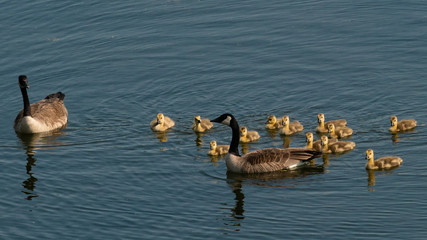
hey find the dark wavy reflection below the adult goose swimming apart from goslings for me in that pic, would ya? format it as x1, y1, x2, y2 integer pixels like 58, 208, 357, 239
16, 131, 64, 200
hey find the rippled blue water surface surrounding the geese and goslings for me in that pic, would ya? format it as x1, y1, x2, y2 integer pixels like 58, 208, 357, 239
0, 0, 427, 239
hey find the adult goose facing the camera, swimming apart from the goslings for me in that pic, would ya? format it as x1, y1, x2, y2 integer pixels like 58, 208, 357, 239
13, 75, 68, 133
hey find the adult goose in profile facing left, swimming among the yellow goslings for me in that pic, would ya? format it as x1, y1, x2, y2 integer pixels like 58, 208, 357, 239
211, 113, 320, 173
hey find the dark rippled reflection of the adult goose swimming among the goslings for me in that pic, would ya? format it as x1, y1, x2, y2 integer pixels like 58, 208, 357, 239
225, 165, 326, 231
